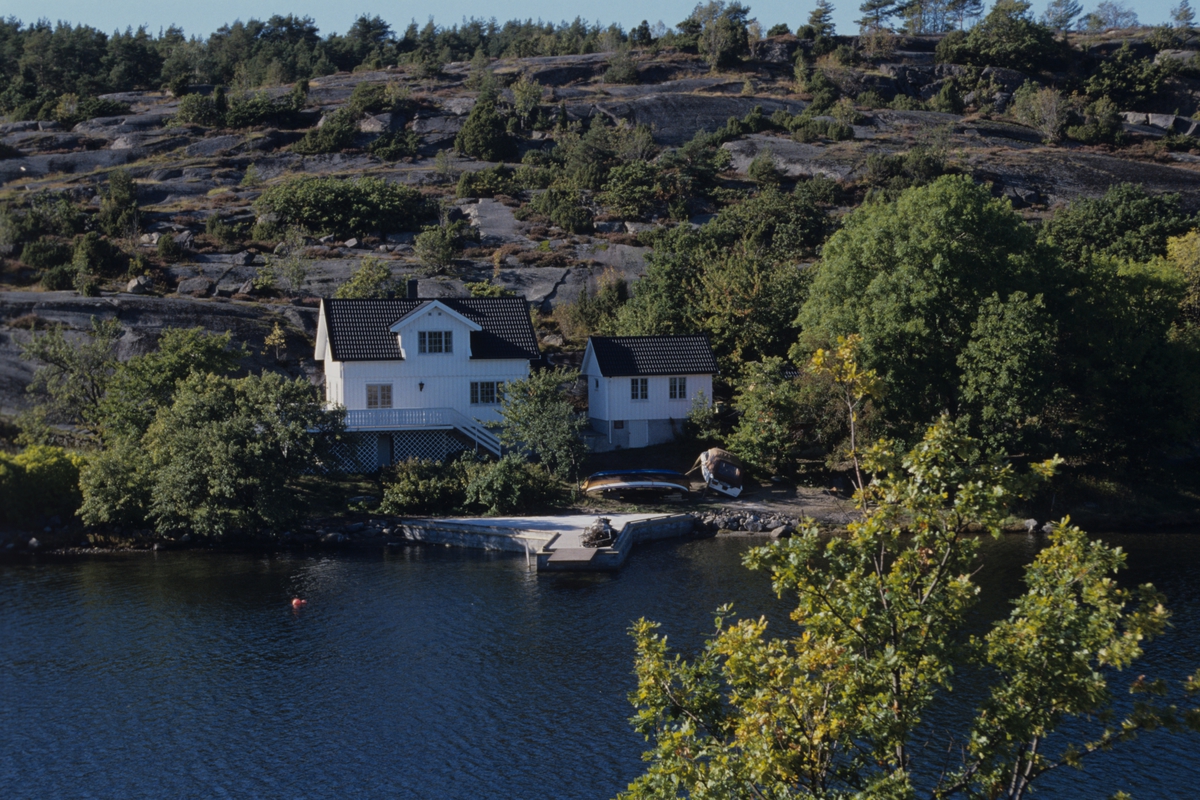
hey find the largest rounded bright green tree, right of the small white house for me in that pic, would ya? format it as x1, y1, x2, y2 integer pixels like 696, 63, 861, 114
793, 176, 1056, 435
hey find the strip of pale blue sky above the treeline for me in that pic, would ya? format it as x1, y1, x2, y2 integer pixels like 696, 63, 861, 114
9, 0, 1185, 36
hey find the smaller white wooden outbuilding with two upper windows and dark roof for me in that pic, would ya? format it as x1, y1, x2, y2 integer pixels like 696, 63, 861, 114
581, 335, 718, 449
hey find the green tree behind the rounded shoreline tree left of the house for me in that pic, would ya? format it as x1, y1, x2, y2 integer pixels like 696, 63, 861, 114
97, 327, 248, 443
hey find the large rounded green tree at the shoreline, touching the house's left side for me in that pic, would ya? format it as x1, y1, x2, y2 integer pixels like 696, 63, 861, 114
144, 373, 341, 536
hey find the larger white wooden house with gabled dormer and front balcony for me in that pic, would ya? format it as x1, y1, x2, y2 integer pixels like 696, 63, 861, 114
316, 292, 540, 469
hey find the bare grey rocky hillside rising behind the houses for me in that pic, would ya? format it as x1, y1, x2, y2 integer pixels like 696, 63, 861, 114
0, 36, 1200, 413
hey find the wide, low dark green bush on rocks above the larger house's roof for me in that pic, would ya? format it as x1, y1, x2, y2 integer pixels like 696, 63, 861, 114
256, 175, 425, 235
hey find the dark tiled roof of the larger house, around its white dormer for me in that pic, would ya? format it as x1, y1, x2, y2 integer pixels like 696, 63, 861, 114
320, 297, 541, 361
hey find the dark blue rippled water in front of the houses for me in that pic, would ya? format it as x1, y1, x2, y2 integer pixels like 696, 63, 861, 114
0, 534, 1200, 800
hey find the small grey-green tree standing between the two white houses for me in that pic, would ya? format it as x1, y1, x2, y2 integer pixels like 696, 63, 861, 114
499, 367, 587, 481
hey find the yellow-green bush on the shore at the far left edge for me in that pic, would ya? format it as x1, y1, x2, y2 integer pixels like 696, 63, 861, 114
0, 445, 83, 524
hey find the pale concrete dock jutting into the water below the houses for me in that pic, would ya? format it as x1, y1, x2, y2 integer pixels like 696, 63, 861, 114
403, 513, 696, 572
